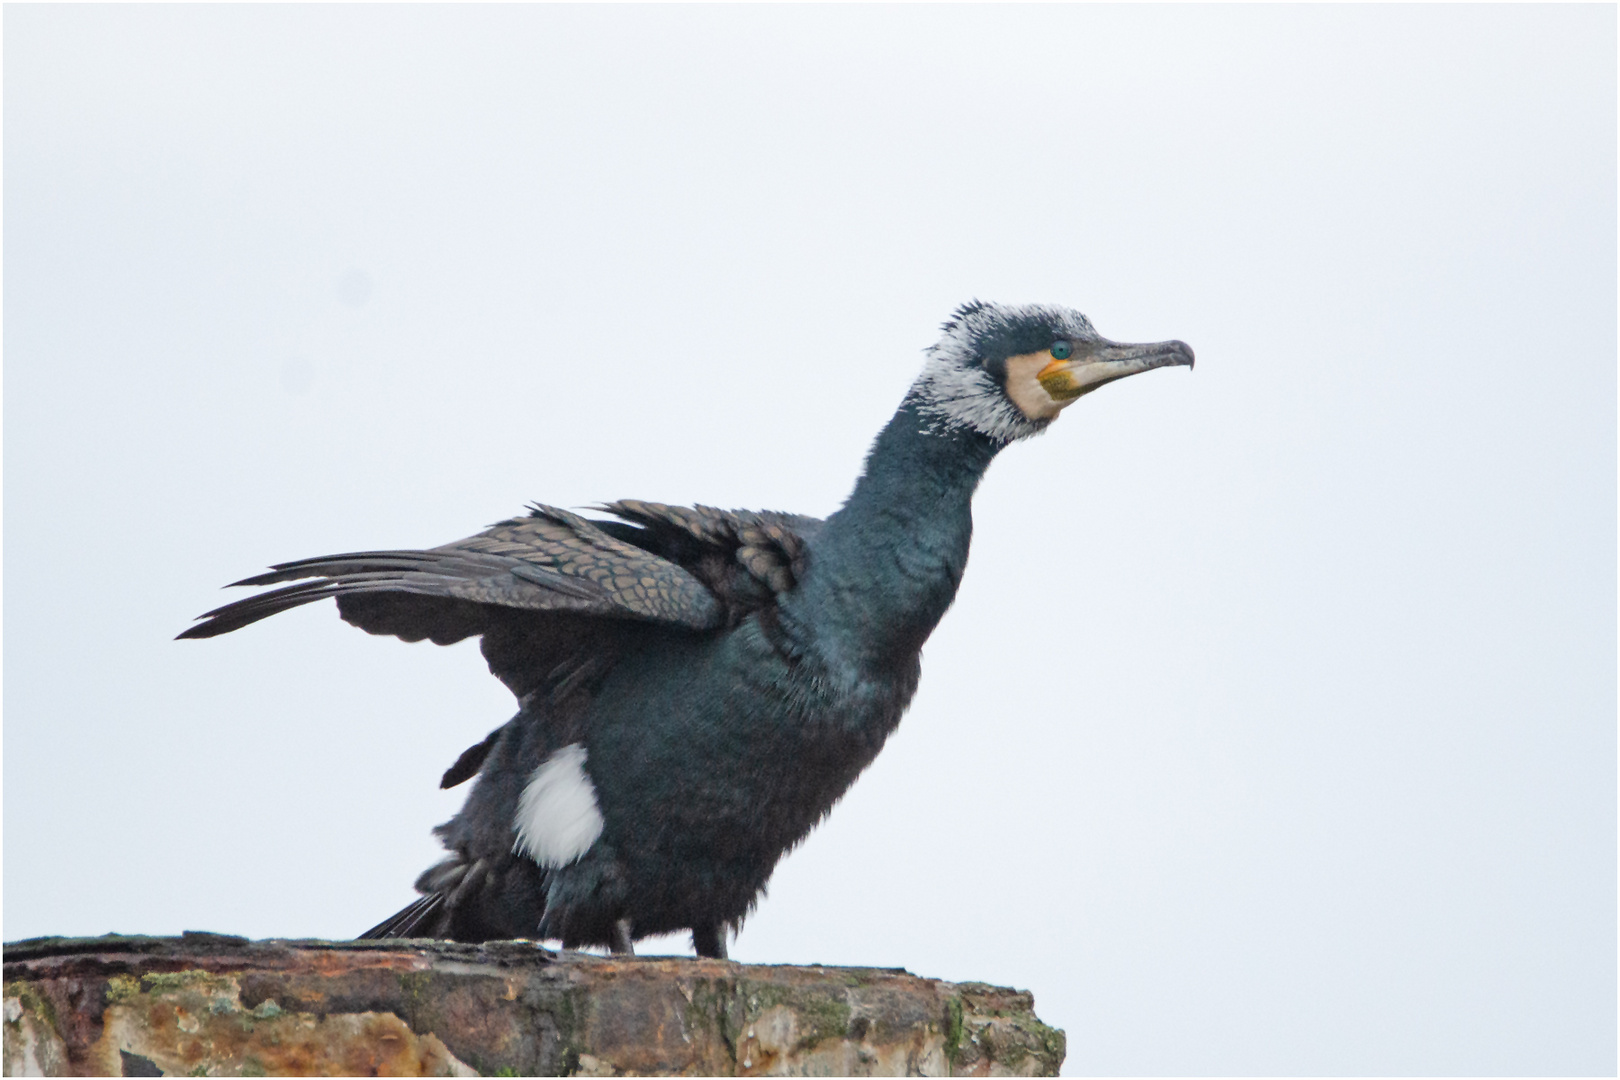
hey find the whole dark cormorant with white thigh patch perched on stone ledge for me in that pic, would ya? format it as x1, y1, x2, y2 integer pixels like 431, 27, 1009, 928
180, 301, 1192, 957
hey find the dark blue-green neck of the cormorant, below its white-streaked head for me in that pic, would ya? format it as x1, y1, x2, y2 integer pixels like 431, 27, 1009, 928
804, 392, 1001, 669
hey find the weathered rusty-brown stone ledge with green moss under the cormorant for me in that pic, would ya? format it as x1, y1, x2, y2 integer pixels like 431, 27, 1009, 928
3, 934, 1064, 1077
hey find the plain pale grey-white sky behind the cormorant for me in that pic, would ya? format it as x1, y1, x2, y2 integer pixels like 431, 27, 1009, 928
3, 5, 1615, 1074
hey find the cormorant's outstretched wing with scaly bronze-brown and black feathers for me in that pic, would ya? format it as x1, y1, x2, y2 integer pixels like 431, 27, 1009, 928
180, 500, 821, 787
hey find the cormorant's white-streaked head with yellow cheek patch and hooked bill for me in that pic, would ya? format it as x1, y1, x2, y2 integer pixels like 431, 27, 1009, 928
912, 300, 1192, 442
